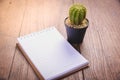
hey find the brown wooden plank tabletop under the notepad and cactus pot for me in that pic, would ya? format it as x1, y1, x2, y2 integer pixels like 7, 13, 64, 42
0, 0, 120, 80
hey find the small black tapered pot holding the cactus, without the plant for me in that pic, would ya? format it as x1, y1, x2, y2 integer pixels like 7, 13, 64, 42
64, 17, 89, 44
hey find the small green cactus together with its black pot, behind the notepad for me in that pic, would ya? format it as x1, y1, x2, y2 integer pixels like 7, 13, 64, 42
64, 4, 89, 44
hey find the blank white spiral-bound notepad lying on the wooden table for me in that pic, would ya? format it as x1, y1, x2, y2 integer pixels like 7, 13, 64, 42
17, 27, 89, 80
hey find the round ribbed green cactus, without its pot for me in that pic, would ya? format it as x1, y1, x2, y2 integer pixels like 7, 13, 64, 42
69, 4, 87, 25
